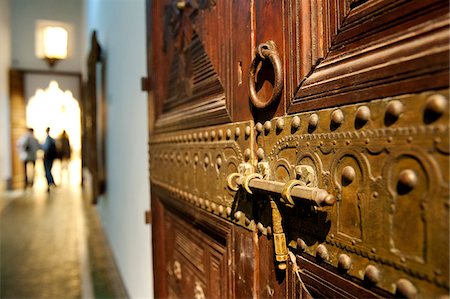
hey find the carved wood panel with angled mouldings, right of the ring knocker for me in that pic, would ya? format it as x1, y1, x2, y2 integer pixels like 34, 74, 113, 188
284, 0, 449, 113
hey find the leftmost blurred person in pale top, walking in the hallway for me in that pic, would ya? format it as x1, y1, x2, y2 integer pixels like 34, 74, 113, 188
17, 128, 41, 189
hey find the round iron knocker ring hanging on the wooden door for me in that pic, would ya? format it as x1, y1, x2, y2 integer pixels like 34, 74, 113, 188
249, 40, 283, 109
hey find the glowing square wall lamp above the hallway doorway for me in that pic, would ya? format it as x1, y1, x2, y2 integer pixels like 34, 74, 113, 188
36, 21, 69, 68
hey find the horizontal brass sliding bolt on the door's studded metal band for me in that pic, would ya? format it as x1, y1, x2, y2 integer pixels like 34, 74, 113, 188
227, 173, 336, 207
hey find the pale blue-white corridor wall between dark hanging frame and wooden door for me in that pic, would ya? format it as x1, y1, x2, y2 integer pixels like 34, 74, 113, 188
84, 0, 153, 298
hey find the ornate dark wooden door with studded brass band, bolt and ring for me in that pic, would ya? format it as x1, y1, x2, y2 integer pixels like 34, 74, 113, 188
146, 0, 449, 298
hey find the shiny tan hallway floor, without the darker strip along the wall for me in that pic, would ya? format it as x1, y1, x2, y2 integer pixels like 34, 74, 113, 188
0, 161, 86, 298
